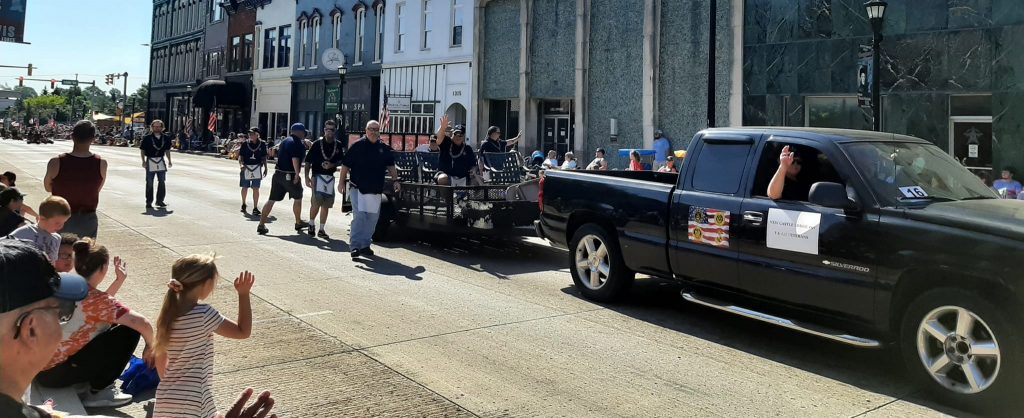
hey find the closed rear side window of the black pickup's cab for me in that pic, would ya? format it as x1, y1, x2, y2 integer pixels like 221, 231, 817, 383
693, 142, 752, 195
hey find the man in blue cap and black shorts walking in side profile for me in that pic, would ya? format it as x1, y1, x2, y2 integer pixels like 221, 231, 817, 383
256, 123, 310, 235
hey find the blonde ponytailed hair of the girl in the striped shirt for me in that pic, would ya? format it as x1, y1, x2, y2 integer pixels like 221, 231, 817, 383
153, 254, 218, 353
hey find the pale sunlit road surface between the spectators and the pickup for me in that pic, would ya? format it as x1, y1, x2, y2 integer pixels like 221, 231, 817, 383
0, 140, 964, 417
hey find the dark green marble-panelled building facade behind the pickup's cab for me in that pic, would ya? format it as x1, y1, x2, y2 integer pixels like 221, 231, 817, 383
742, 0, 1024, 175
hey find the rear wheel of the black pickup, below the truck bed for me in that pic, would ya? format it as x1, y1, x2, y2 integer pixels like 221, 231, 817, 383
569, 223, 635, 302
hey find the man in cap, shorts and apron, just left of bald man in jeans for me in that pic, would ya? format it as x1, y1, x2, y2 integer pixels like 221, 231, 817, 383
305, 121, 345, 240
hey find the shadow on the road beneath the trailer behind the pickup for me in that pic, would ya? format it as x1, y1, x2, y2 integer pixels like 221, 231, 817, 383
374, 233, 566, 280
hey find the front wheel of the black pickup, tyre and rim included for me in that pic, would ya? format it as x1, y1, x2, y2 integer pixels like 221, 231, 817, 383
900, 288, 1024, 412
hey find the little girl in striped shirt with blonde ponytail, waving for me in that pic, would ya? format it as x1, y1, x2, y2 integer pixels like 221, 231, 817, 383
153, 254, 256, 418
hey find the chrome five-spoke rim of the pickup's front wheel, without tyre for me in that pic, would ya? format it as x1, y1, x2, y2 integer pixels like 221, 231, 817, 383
918, 306, 1001, 394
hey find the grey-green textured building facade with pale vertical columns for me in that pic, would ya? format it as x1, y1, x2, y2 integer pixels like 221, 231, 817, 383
473, 0, 742, 166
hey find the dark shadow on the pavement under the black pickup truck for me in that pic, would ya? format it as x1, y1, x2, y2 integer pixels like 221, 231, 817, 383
562, 278, 970, 416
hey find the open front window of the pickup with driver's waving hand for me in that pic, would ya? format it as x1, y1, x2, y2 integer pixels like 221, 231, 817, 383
751, 141, 846, 202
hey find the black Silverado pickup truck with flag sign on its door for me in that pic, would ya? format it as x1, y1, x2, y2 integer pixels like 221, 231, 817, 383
537, 128, 1024, 410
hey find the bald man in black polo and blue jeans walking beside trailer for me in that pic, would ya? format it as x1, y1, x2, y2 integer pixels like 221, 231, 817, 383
338, 121, 399, 259
